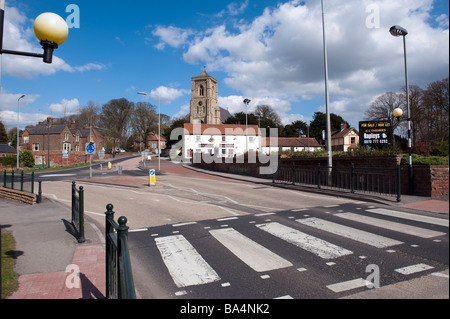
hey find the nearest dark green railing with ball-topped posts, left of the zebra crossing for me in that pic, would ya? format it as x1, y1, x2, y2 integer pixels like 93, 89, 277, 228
105, 204, 136, 299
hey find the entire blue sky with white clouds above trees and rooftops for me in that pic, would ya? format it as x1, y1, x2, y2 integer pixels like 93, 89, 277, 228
0, 0, 449, 131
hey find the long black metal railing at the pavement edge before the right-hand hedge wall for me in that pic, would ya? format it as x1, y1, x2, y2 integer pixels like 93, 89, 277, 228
272, 164, 401, 202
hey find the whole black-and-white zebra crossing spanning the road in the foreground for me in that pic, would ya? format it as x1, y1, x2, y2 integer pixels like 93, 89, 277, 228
129, 205, 448, 299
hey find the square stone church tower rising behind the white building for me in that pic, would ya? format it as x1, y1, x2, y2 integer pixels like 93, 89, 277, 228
190, 71, 222, 124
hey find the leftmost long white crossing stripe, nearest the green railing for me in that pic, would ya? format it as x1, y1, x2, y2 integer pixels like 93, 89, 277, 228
155, 235, 220, 288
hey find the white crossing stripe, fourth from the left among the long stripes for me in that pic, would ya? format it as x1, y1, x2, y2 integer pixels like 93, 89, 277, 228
296, 218, 403, 248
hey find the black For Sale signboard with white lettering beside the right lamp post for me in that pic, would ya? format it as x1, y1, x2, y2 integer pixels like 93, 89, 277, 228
359, 121, 392, 147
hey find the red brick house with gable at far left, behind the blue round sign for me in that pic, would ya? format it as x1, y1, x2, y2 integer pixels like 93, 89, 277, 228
20, 117, 104, 165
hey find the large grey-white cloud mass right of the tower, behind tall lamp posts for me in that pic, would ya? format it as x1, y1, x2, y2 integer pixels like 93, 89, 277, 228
151, 0, 449, 127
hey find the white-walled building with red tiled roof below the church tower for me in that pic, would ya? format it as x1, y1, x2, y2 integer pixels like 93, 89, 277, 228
183, 123, 261, 161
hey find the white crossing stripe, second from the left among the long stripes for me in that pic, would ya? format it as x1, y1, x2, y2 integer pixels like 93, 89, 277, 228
209, 228, 292, 272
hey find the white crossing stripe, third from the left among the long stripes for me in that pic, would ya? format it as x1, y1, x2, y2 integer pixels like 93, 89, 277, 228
256, 223, 353, 259
